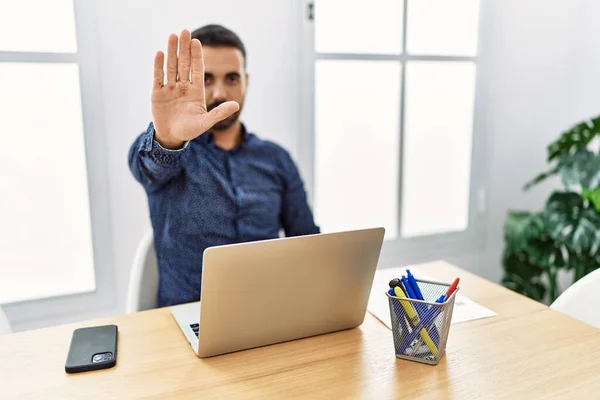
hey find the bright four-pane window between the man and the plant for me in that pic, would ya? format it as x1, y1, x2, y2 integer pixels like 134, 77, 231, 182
300, 0, 483, 260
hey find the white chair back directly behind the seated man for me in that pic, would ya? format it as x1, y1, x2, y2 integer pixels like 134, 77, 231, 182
126, 231, 158, 314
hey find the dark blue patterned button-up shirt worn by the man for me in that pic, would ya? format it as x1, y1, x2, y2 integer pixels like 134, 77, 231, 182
129, 123, 319, 307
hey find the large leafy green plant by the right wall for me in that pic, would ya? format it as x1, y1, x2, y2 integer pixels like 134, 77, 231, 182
502, 116, 600, 302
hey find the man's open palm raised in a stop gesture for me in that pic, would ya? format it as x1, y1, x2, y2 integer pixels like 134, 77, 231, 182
152, 30, 239, 149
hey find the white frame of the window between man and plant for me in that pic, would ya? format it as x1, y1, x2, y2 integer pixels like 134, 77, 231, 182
298, 0, 488, 268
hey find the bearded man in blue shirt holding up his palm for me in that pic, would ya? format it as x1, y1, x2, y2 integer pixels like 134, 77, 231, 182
129, 25, 319, 307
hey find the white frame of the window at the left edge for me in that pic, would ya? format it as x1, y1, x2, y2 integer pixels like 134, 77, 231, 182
0, 0, 117, 327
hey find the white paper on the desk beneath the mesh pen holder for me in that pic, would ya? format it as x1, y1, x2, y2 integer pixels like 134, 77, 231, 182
367, 268, 496, 329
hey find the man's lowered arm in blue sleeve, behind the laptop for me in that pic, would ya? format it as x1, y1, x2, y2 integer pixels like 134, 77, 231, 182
281, 152, 321, 236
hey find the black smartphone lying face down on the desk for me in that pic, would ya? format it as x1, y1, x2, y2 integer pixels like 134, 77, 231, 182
65, 325, 119, 374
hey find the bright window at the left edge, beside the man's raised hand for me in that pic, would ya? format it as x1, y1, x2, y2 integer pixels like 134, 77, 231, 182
0, 0, 107, 310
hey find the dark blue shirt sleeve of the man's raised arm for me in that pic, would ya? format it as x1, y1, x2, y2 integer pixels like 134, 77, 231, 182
129, 122, 189, 192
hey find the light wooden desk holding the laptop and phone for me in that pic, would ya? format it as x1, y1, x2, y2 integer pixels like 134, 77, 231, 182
0, 262, 600, 400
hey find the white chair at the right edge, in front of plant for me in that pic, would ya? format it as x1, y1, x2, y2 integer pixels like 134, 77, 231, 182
550, 269, 600, 328
